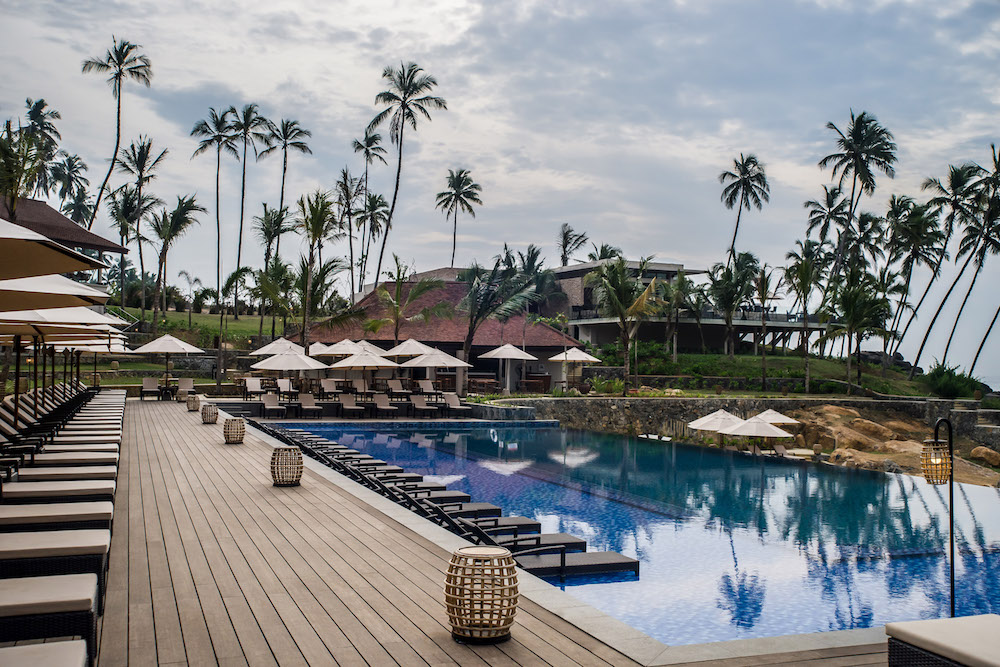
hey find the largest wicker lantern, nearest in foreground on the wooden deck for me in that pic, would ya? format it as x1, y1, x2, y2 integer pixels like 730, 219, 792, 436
444, 547, 518, 644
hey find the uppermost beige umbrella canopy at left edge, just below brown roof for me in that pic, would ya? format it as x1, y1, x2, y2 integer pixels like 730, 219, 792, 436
0, 218, 108, 280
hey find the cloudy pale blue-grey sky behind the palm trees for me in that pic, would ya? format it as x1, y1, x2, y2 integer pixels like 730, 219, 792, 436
0, 0, 1000, 385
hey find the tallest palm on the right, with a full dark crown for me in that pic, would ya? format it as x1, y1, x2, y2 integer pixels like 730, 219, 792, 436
819, 109, 896, 275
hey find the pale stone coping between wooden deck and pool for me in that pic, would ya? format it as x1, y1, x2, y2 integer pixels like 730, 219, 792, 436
238, 410, 886, 667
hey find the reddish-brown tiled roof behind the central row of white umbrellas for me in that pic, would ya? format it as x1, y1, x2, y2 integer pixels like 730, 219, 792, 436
309, 282, 581, 350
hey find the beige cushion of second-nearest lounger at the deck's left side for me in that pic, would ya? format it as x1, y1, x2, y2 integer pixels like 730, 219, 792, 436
0, 573, 97, 617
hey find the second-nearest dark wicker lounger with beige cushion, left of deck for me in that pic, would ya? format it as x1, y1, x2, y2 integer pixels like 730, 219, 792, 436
0, 574, 98, 665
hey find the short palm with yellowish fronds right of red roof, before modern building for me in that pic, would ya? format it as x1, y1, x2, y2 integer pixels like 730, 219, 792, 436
584, 257, 657, 395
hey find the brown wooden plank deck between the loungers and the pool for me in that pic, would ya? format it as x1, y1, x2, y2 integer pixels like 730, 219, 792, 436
99, 400, 635, 667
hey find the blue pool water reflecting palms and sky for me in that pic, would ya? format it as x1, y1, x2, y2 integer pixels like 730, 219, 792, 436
296, 424, 1000, 644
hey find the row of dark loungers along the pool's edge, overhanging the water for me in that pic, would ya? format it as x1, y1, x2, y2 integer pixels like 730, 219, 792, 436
255, 424, 639, 577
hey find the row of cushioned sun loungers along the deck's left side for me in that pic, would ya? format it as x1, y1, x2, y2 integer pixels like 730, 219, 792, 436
0, 383, 125, 667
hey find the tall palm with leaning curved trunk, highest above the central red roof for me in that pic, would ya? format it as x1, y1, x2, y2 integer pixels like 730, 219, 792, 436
367, 62, 448, 284
